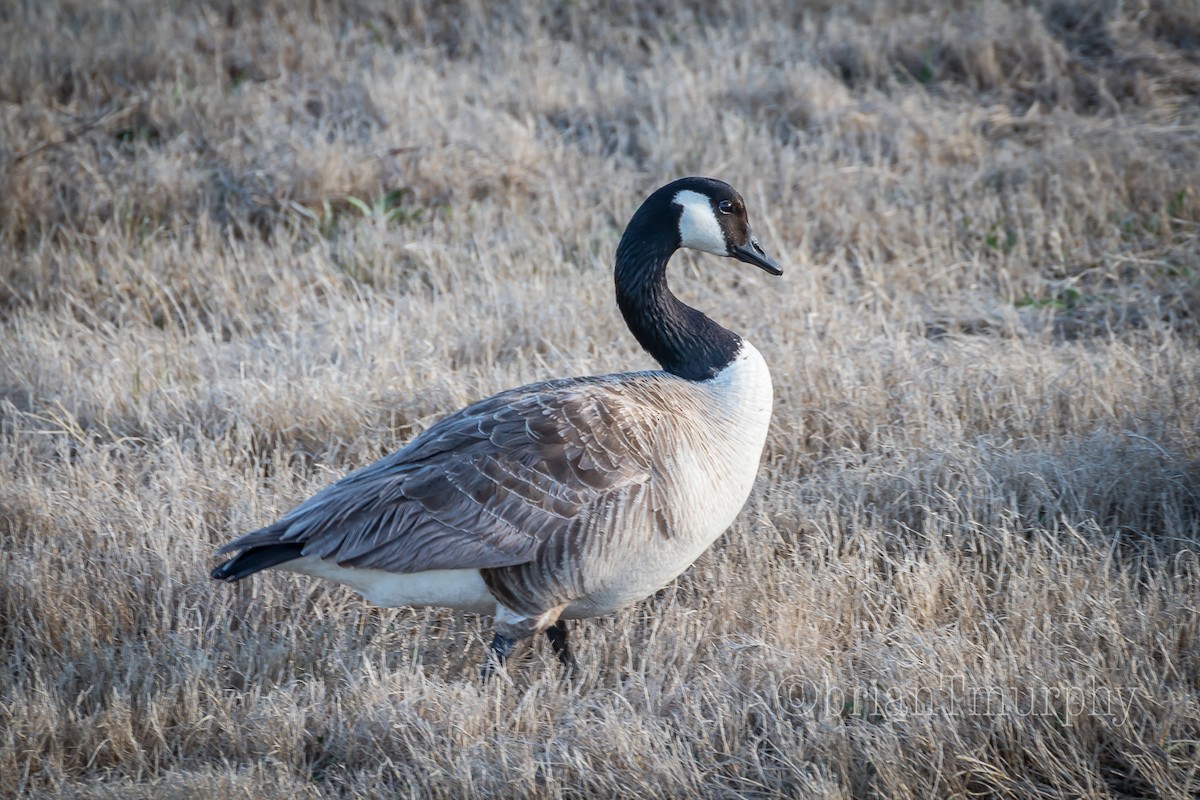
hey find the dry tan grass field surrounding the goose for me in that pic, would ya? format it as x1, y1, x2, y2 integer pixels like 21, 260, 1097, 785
0, 0, 1200, 799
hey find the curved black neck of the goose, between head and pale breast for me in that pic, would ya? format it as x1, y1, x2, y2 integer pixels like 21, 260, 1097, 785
616, 206, 742, 380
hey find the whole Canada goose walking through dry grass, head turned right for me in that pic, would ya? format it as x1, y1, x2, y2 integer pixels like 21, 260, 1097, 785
212, 178, 782, 675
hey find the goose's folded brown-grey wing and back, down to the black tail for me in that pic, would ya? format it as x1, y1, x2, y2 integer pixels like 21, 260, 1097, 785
220, 375, 661, 572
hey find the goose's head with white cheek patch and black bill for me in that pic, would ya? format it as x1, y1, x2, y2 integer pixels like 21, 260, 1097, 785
660, 178, 784, 275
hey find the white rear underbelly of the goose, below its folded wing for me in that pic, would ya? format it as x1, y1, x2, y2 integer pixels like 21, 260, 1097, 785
280, 555, 496, 614
